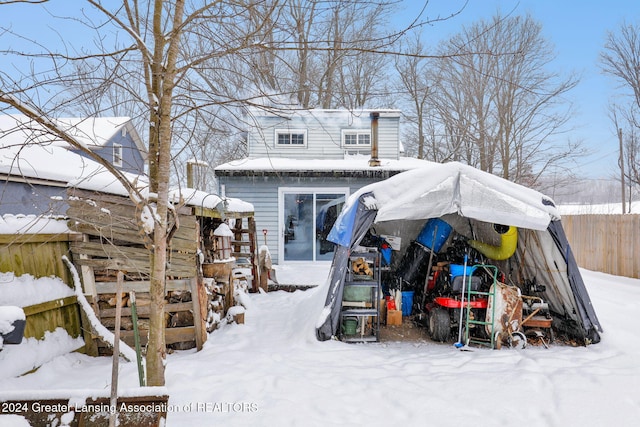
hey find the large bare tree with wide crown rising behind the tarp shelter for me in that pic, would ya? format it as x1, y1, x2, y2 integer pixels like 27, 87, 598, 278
424, 15, 579, 185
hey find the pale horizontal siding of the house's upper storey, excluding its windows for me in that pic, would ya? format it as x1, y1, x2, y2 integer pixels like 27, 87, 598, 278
248, 110, 400, 160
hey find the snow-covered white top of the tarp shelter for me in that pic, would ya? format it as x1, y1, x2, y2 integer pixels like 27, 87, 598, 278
345, 162, 560, 234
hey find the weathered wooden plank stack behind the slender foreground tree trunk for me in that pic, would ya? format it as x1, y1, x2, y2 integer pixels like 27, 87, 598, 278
67, 189, 208, 354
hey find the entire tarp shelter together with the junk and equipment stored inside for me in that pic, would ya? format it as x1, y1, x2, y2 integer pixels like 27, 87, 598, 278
316, 163, 602, 348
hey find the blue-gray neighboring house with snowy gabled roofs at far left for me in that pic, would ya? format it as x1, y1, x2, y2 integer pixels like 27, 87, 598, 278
0, 115, 146, 215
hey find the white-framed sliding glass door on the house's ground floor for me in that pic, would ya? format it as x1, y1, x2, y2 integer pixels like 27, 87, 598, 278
279, 188, 349, 261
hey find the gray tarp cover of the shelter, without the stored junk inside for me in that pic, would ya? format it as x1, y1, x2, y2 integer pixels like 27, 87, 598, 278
316, 162, 602, 344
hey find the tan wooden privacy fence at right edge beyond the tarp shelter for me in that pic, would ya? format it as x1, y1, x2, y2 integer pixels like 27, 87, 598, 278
562, 214, 640, 278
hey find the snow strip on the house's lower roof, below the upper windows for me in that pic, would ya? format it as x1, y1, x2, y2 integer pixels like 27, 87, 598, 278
215, 155, 430, 172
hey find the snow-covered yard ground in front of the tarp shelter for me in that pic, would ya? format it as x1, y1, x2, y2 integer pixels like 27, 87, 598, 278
0, 265, 640, 427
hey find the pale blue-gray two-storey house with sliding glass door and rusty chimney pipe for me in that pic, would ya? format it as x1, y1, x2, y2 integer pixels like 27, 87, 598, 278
215, 110, 424, 264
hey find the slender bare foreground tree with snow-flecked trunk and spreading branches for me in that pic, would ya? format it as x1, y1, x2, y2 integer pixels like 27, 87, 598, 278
0, 0, 286, 386
